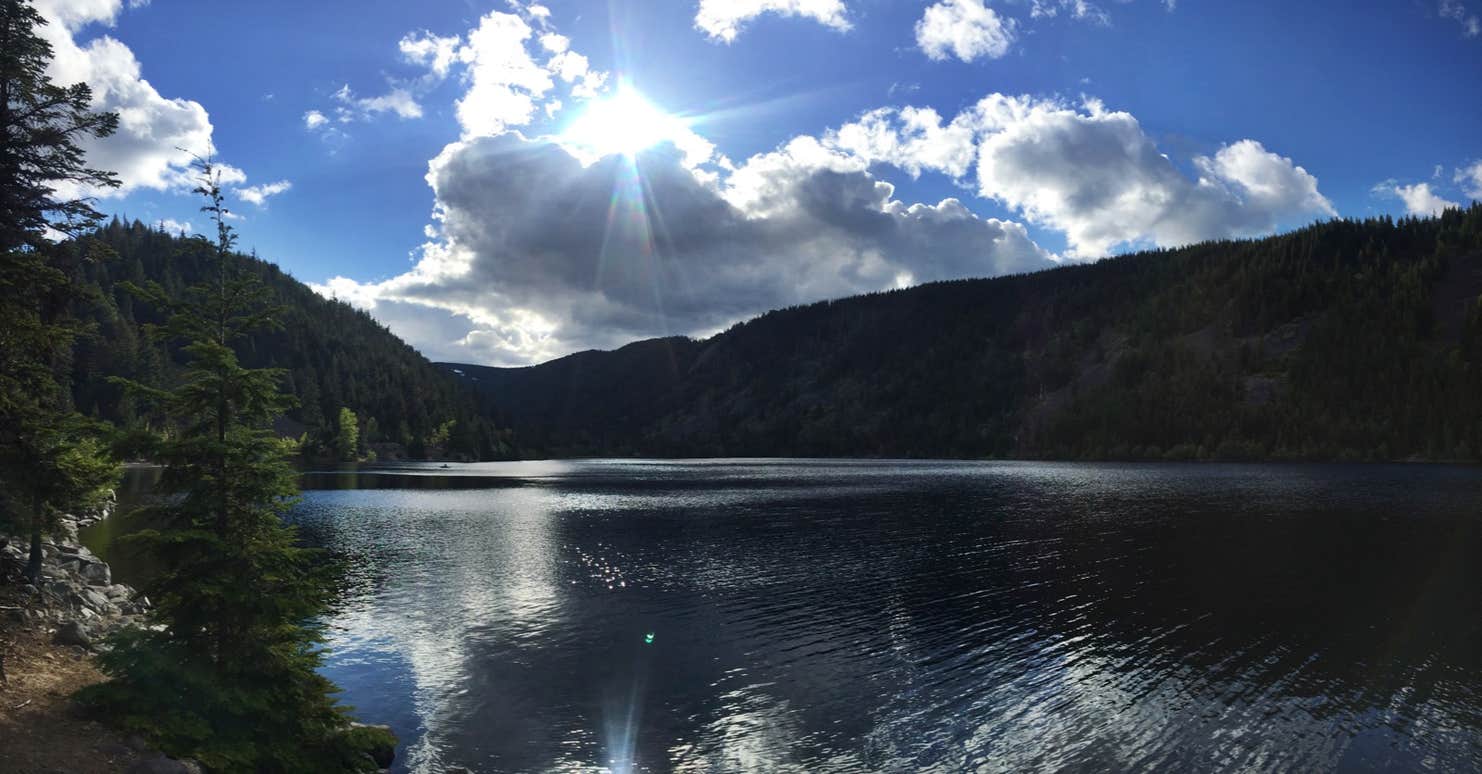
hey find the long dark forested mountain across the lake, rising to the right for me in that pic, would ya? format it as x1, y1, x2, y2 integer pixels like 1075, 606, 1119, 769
445, 205, 1482, 460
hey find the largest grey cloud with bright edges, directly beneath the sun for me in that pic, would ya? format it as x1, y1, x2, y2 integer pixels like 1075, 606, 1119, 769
312, 133, 1052, 362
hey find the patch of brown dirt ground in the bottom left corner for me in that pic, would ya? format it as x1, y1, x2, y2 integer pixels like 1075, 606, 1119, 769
0, 607, 141, 774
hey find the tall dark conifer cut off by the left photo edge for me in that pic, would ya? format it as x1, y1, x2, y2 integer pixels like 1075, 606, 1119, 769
0, 0, 119, 580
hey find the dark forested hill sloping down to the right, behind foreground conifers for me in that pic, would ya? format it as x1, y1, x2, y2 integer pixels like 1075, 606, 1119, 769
71, 219, 513, 460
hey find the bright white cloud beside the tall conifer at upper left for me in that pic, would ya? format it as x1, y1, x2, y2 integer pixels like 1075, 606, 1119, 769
34, 0, 212, 196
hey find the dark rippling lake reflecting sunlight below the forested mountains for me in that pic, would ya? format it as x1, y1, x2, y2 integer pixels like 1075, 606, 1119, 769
133, 460, 1482, 773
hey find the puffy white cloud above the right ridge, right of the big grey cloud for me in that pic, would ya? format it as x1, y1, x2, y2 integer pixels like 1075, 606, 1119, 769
824, 93, 1337, 258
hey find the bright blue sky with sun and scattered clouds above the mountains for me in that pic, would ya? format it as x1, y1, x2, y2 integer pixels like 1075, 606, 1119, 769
33, 0, 1482, 365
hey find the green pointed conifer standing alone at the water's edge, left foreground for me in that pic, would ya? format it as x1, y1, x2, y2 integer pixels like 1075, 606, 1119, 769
83, 162, 394, 773
